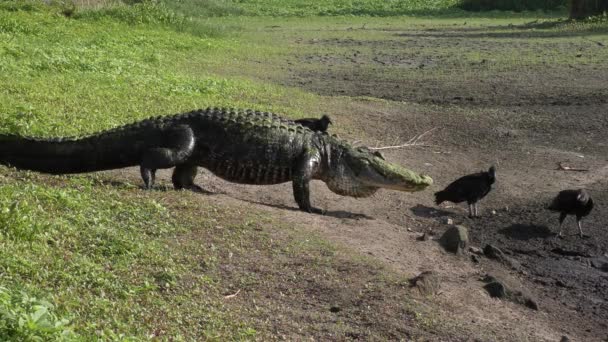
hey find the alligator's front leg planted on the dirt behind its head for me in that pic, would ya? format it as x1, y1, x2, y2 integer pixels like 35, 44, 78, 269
292, 153, 322, 214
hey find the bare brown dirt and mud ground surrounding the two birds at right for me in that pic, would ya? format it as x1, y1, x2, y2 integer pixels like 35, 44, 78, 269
117, 22, 608, 341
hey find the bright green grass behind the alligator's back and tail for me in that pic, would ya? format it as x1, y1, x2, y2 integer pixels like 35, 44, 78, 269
0, 1, 315, 136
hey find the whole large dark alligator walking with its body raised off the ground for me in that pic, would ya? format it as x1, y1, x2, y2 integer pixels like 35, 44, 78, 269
0, 108, 433, 212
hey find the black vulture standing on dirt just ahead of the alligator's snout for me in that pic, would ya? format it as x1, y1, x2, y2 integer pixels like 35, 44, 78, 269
435, 166, 496, 217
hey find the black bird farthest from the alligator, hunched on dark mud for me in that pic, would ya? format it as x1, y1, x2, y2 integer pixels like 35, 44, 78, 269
547, 189, 593, 237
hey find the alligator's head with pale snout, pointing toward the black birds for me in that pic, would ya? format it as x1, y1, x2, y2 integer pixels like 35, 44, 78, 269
323, 142, 433, 197
